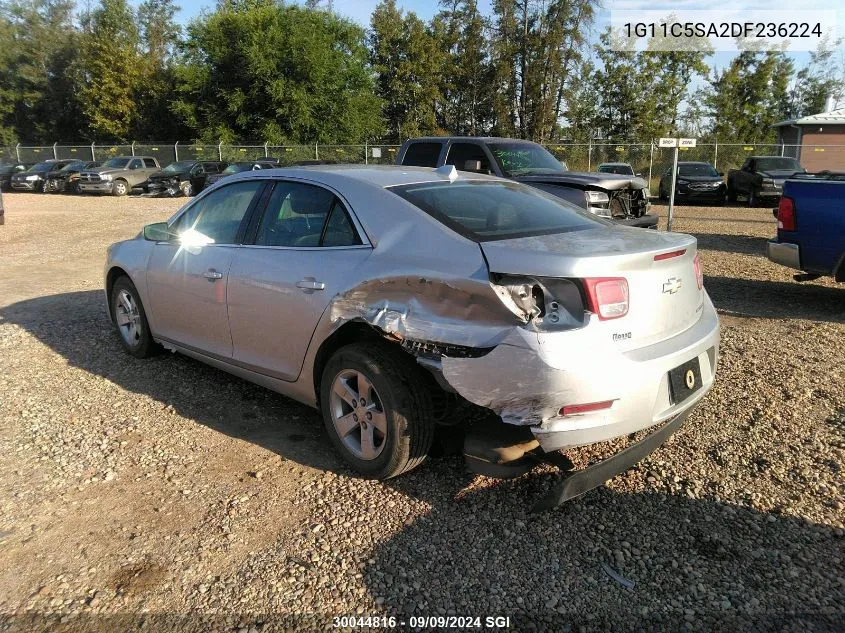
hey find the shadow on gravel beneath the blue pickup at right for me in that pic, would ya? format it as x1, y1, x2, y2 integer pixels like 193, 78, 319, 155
704, 274, 845, 323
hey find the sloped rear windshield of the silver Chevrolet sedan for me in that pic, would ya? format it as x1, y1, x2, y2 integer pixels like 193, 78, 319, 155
388, 180, 605, 242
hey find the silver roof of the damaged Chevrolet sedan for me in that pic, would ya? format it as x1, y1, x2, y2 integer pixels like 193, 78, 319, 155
231, 165, 502, 188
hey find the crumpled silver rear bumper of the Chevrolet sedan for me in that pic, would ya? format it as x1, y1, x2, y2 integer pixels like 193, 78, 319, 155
442, 294, 719, 452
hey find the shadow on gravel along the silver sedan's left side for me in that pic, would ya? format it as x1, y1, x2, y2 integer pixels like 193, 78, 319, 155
0, 290, 347, 472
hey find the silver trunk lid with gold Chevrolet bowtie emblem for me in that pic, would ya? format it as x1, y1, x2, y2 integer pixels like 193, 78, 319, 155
480, 227, 704, 349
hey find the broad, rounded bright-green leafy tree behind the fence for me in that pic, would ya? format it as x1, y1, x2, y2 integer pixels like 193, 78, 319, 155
173, 0, 382, 144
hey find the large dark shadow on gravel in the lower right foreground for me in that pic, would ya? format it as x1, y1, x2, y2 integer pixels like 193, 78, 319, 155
358, 460, 845, 631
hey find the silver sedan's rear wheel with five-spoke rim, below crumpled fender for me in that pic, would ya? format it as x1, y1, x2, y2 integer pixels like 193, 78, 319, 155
320, 343, 435, 479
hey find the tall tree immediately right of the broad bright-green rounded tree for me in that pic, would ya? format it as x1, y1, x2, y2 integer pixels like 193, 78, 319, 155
369, 0, 443, 141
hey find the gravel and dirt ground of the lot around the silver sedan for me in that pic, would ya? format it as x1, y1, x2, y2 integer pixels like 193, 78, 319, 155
0, 194, 845, 632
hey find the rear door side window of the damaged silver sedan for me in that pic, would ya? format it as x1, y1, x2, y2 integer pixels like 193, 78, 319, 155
255, 182, 361, 247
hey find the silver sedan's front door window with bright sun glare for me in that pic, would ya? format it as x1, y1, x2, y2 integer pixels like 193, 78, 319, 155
171, 180, 264, 245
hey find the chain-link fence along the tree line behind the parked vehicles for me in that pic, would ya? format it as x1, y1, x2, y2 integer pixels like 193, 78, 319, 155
0, 141, 828, 190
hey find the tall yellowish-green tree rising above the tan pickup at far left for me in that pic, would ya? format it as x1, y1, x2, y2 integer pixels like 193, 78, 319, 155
79, 0, 141, 141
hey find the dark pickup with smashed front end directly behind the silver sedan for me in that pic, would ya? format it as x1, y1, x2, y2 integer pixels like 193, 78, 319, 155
396, 136, 657, 228
